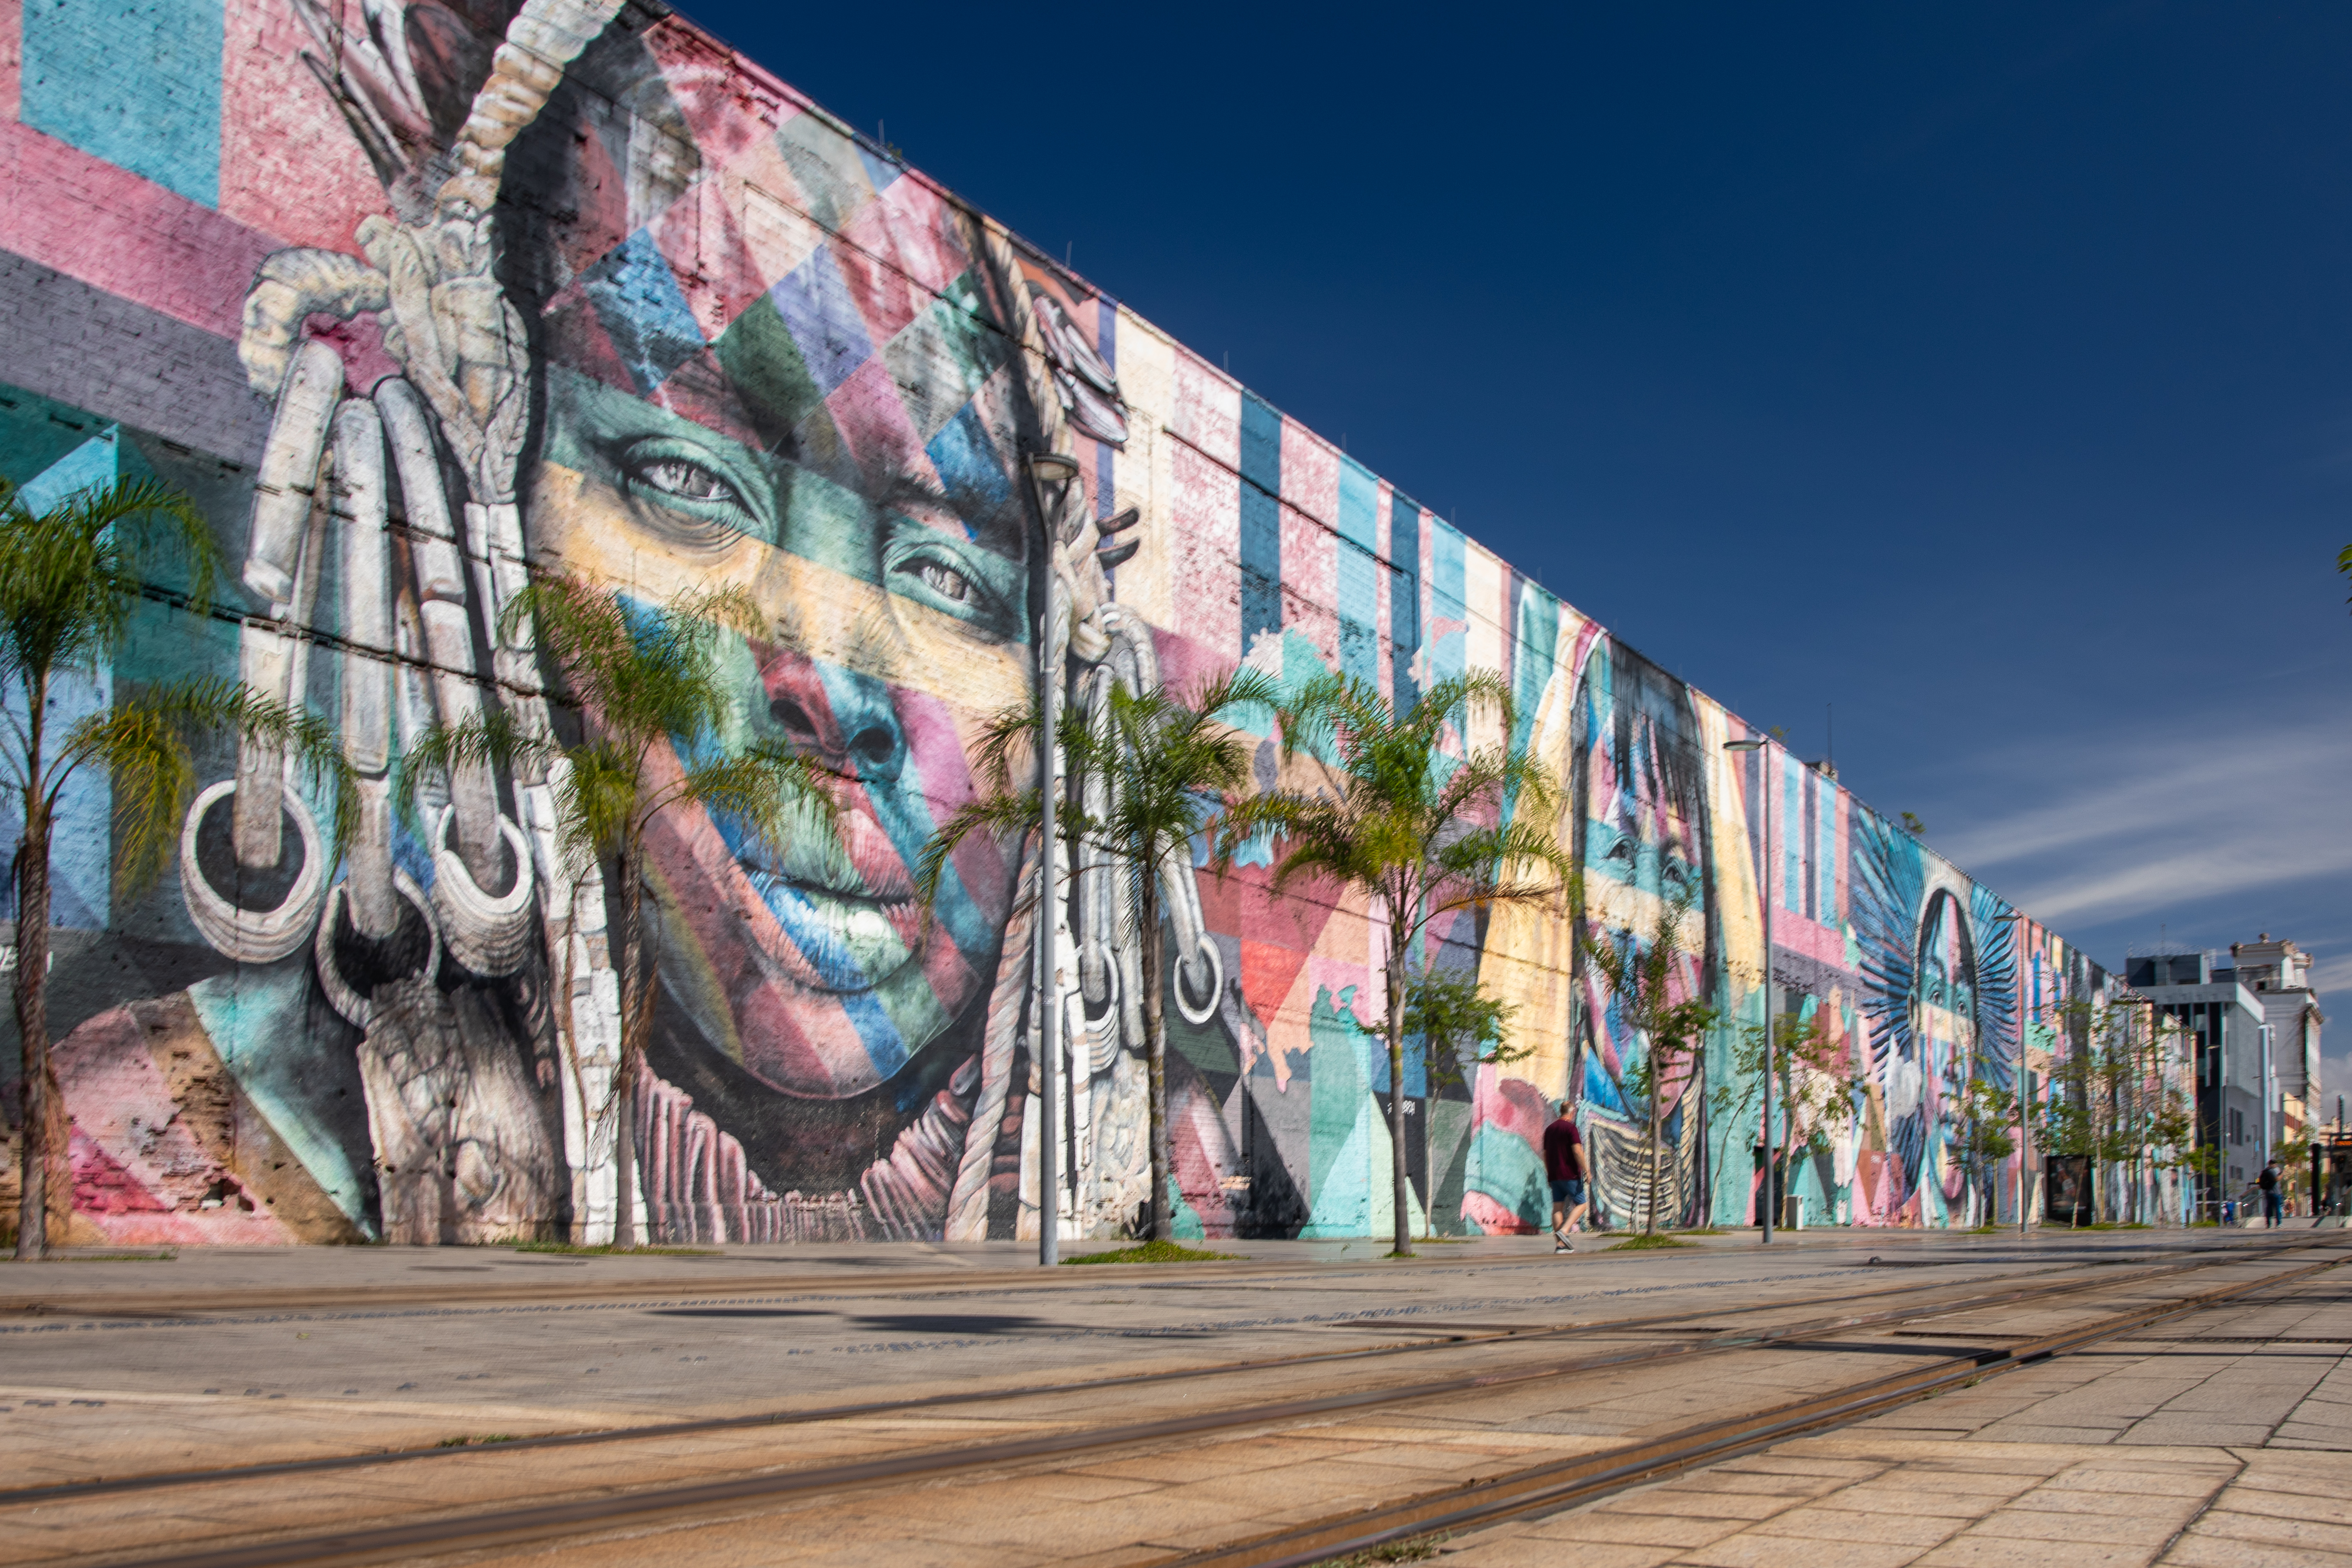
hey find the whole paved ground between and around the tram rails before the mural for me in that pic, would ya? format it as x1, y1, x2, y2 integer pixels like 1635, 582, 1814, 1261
0, 1232, 2352, 1568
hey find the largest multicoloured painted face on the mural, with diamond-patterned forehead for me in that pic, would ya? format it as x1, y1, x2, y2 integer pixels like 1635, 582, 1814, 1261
529, 175, 1028, 1098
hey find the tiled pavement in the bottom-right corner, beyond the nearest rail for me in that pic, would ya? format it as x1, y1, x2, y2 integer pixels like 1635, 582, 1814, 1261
1442, 1272, 2352, 1568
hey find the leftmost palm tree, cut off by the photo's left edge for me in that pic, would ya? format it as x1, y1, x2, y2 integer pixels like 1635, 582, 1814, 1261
0, 479, 358, 1258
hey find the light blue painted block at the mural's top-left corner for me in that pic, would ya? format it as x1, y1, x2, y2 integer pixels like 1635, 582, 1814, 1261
19, 0, 225, 207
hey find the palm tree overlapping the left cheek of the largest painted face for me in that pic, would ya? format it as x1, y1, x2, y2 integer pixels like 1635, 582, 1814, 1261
395, 576, 835, 1248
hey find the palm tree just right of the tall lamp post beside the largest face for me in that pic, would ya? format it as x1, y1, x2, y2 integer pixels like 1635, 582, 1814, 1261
919, 670, 1282, 1241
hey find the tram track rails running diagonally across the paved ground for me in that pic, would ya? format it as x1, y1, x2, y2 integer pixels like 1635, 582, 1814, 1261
27, 1237, 2340, 1568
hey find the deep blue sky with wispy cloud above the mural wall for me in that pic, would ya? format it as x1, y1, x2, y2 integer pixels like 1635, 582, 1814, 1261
684, 0, 2352, 1084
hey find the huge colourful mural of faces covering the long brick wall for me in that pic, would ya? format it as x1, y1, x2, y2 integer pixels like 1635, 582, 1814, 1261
0, 0, 2105, 1244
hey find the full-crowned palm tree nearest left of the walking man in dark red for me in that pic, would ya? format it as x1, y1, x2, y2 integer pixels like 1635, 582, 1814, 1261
1216, 670, 1578, 1258
